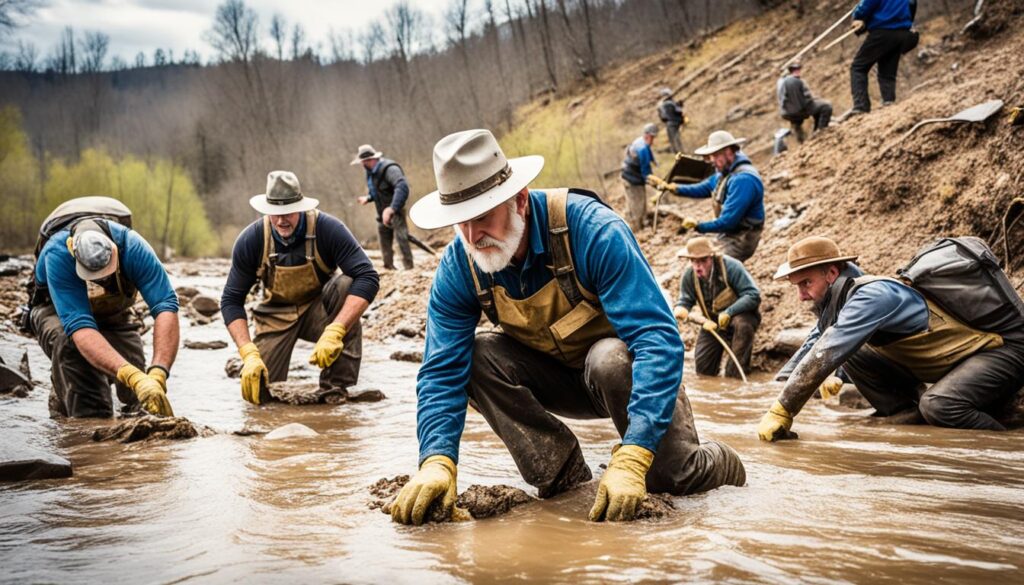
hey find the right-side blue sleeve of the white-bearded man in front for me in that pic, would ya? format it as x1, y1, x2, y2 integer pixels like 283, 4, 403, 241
569, 213, 683, 451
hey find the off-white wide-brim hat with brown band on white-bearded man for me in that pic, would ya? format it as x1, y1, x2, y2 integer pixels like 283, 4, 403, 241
409, 129, 544, 229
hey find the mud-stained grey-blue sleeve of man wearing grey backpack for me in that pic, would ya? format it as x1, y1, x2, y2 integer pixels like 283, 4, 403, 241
778, 281, 929, 415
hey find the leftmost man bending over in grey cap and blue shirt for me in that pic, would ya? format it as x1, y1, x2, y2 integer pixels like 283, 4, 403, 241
30, 197, 179, 417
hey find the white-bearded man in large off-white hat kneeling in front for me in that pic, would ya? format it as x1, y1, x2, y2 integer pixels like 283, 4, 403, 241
391, 130, 745, 524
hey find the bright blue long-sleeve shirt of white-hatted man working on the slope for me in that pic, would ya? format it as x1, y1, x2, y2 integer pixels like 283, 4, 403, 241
676, 152, 765, 234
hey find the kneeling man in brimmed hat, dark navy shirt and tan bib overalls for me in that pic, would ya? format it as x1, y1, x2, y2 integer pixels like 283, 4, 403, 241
220, 171, 380, 405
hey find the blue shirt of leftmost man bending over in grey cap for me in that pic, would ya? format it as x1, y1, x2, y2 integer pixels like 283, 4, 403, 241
36, 221, 178, 337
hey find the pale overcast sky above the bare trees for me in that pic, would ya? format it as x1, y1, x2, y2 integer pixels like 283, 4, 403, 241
7, 0, 452, 62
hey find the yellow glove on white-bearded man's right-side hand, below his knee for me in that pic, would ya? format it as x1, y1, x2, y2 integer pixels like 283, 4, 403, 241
590, 445, 654, 523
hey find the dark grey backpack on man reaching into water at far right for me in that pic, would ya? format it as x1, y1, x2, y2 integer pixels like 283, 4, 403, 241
897, 237, 1024, 335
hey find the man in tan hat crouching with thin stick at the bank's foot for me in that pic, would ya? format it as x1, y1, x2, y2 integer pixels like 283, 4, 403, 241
673, 236, 761, 378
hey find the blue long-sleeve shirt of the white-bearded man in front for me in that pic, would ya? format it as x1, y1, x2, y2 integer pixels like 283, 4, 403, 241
416, 191, 683, 462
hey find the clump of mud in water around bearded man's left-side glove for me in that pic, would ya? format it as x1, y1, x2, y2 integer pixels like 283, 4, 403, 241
369, 475, 535, 523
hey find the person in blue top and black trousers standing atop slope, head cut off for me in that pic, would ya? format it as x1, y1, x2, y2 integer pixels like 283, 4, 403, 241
850, 0, 918, 114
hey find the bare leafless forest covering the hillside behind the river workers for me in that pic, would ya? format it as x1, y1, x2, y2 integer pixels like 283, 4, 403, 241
0, 0, 770, 252
